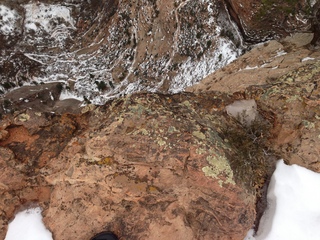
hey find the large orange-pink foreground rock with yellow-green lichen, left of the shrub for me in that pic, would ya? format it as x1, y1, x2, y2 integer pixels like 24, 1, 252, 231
0, 93, 264, 240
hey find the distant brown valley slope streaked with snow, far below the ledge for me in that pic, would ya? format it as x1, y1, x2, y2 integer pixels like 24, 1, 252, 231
0, 0, 242, 104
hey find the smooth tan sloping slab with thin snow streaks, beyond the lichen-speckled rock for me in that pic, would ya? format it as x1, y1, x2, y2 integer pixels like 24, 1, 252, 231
186, 34, 320, 94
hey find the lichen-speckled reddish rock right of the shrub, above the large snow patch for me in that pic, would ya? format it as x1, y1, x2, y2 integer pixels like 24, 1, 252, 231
254, 61, 320, 172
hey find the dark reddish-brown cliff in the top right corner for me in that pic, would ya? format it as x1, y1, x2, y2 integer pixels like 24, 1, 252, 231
225, 0, 320, 42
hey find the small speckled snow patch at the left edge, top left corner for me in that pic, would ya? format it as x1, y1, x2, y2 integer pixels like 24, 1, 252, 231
0, 5, 19, 35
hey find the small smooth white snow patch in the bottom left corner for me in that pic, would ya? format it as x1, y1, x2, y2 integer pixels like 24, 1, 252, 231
5, 207, 53, 240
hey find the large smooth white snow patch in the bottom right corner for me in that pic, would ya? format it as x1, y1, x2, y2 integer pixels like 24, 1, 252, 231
245, 160, 320, 240
